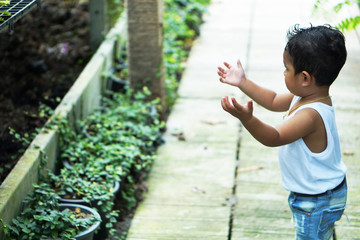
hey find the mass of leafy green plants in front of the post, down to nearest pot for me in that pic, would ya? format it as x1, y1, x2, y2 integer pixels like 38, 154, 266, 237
2, 88, 164, 239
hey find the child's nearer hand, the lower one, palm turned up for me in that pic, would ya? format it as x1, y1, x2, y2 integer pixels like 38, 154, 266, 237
221, 96, 253, 122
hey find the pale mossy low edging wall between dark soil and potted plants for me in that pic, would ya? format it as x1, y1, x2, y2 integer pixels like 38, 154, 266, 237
0, 14, 127, 240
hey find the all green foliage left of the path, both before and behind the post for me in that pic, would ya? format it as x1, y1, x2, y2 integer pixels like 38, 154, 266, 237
0, 0, 210, 239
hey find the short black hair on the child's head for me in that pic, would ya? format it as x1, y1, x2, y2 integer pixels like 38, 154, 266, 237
285, 25, 347, 86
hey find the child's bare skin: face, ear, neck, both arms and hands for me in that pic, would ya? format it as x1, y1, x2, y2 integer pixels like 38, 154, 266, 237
218, 51, 332, 153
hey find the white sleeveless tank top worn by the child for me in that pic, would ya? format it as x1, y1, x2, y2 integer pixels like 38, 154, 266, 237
279, 96, 347, 194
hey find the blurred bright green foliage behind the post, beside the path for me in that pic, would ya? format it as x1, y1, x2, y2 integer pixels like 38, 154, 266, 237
163, 0, 210, 107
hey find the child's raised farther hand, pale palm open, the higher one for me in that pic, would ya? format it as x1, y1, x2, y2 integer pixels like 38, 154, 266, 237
217, 60, 246, 87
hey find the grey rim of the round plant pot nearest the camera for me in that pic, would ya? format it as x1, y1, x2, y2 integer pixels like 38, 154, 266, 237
42, 204, 101, 240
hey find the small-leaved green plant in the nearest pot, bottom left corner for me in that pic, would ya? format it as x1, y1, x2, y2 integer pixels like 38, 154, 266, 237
3, 183, 100, 240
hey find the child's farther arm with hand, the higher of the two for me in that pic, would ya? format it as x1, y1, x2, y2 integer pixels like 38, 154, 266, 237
218, 60, 294, 112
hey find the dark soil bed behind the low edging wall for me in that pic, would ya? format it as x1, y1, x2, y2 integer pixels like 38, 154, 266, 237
0, 0, 93, 183
